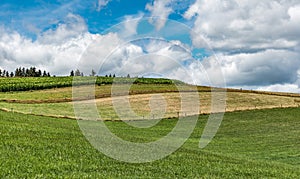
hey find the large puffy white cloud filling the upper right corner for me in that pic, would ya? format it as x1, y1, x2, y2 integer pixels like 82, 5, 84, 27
184, 0, 300, 52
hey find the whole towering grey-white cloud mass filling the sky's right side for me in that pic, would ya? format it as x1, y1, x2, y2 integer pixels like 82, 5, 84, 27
184, 0, 300, 91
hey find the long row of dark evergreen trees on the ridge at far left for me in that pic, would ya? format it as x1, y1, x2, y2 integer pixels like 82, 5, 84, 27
0, 67, 51, 77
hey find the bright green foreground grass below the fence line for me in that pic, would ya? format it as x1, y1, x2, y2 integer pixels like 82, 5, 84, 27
0, 108, 300, 178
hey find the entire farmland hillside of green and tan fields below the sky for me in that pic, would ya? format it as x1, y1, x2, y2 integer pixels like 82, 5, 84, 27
0, 77, 300, 178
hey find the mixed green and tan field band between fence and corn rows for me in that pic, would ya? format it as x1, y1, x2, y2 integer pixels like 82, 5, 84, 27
0, 84, 300, 120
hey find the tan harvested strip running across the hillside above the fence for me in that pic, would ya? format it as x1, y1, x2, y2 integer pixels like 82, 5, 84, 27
0, 92, 299, 120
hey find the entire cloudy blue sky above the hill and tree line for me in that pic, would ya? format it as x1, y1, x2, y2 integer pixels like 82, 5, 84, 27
0, 0, 300, 93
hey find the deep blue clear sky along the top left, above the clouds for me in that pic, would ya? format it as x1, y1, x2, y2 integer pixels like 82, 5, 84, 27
0, 0, 193, 38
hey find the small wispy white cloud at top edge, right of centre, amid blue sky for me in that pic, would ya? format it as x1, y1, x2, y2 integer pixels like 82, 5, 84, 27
146, 0, 173, 30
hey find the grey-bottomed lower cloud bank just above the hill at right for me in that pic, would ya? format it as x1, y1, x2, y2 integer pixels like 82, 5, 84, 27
183, 50, 300, 89
